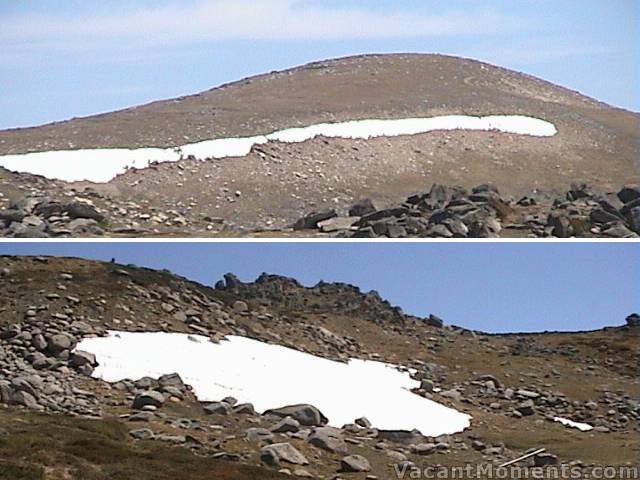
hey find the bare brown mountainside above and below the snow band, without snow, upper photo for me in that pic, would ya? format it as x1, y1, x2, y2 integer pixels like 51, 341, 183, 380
0, 54, 640, 231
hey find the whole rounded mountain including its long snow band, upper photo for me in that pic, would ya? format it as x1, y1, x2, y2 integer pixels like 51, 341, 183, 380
0, 54, 640, 235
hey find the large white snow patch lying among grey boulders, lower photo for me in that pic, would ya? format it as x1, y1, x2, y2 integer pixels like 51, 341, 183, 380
77, 332, 471, 436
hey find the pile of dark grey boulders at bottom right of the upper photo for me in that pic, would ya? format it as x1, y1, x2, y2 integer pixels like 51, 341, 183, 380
294, 184, 640, 238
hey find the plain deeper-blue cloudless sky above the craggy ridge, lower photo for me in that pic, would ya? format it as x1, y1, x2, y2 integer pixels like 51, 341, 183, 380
0, 243, 640, 332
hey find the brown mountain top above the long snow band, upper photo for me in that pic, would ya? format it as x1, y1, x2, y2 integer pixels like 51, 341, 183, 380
0, 54, 638, 154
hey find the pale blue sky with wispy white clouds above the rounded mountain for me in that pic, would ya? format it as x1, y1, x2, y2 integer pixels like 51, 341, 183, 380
0, 0, 640, 128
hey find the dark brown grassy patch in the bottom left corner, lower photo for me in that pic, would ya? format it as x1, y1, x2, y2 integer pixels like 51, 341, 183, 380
0, 407, 290, 480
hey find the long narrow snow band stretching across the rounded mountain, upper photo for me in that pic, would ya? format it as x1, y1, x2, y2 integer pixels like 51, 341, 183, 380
0, 115, 557, 183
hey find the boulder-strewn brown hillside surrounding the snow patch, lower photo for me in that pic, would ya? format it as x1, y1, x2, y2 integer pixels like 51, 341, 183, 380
0, 257, 640, 479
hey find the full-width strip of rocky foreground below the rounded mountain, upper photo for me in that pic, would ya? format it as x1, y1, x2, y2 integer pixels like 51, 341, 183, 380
0, 175, 640, 238
